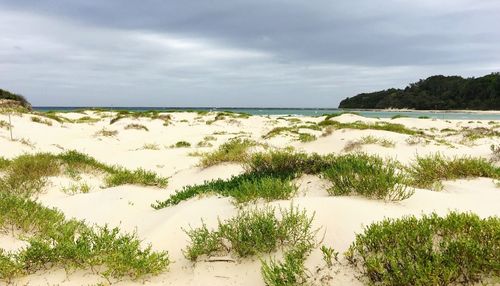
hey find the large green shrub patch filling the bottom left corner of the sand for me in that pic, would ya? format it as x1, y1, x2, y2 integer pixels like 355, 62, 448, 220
0, 192, 169, 281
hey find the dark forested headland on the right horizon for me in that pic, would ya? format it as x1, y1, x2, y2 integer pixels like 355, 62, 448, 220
339, 73, 500, 110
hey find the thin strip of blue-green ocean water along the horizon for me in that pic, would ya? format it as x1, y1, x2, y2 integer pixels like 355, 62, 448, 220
33, 106, 500, 120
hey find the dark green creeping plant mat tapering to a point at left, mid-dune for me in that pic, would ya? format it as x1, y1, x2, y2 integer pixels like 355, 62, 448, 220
152, 173, 297, 209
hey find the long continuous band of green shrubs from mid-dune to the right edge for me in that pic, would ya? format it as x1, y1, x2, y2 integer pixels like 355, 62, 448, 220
152, 150, 500, 209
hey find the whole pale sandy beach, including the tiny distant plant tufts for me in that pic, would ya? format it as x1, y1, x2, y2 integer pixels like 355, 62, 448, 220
0, 111, 500, 285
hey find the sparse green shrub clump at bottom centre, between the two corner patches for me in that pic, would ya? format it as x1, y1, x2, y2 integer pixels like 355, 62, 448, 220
184, 205, 319, 286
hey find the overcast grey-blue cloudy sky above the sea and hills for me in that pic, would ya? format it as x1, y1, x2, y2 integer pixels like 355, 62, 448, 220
0, 0, 500, 108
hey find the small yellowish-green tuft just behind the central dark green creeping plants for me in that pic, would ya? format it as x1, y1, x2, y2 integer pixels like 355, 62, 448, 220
200, 138, 257, 168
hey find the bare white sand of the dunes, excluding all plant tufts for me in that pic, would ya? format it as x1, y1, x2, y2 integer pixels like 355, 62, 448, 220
0, 112, 500, 285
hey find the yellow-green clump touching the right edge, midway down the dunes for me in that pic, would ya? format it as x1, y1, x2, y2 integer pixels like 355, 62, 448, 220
408, 154, 500, 189
